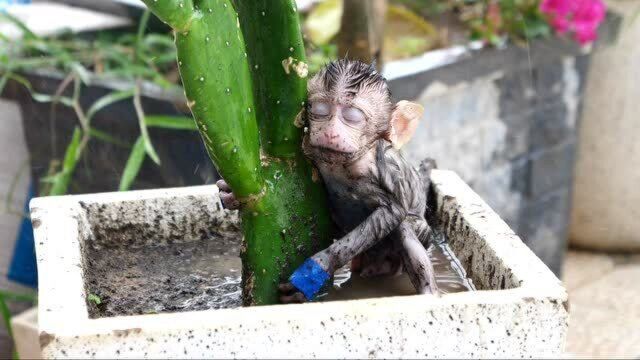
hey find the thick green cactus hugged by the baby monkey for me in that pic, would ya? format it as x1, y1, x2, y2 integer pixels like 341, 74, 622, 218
144, 0, 331, 305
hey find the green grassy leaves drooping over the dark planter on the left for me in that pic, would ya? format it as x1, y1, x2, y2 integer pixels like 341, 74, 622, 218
0, 12, 196, 195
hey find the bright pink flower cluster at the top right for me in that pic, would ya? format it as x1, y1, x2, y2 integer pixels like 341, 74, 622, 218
540, 0, 606, 45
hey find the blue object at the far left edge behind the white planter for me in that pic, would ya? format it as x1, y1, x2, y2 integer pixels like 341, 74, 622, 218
7, 184, 38, 288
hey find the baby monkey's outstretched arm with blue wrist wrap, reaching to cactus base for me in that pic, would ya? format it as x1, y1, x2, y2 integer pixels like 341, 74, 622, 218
281, 204, 407, 302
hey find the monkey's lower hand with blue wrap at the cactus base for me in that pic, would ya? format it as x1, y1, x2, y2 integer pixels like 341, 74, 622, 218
278, 258, 333, 304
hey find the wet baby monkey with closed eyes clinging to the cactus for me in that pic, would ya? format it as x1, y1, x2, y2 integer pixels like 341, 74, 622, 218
218, 59, 437, 303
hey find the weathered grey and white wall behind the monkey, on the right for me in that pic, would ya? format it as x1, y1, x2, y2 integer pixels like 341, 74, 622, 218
390, 39, 589, 273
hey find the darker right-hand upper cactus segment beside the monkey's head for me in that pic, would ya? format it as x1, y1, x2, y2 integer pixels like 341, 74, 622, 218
236, 0, 308, 158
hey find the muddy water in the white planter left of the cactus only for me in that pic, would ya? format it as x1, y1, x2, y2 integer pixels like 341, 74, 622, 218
85, 225, 242, 318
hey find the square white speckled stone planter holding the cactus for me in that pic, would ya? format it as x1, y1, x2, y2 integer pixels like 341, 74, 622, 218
31, 171, 568, 358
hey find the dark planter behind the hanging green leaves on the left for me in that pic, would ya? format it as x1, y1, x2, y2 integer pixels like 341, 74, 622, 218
2, 72, 218, 194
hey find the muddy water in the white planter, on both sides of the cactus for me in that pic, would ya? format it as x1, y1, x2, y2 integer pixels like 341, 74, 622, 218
85, 227, 474, 318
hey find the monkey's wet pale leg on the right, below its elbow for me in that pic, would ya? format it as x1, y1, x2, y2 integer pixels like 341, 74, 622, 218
397, 221, 438, 294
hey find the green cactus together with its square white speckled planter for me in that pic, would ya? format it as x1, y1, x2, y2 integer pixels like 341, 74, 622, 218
31, 0, 567, 357
